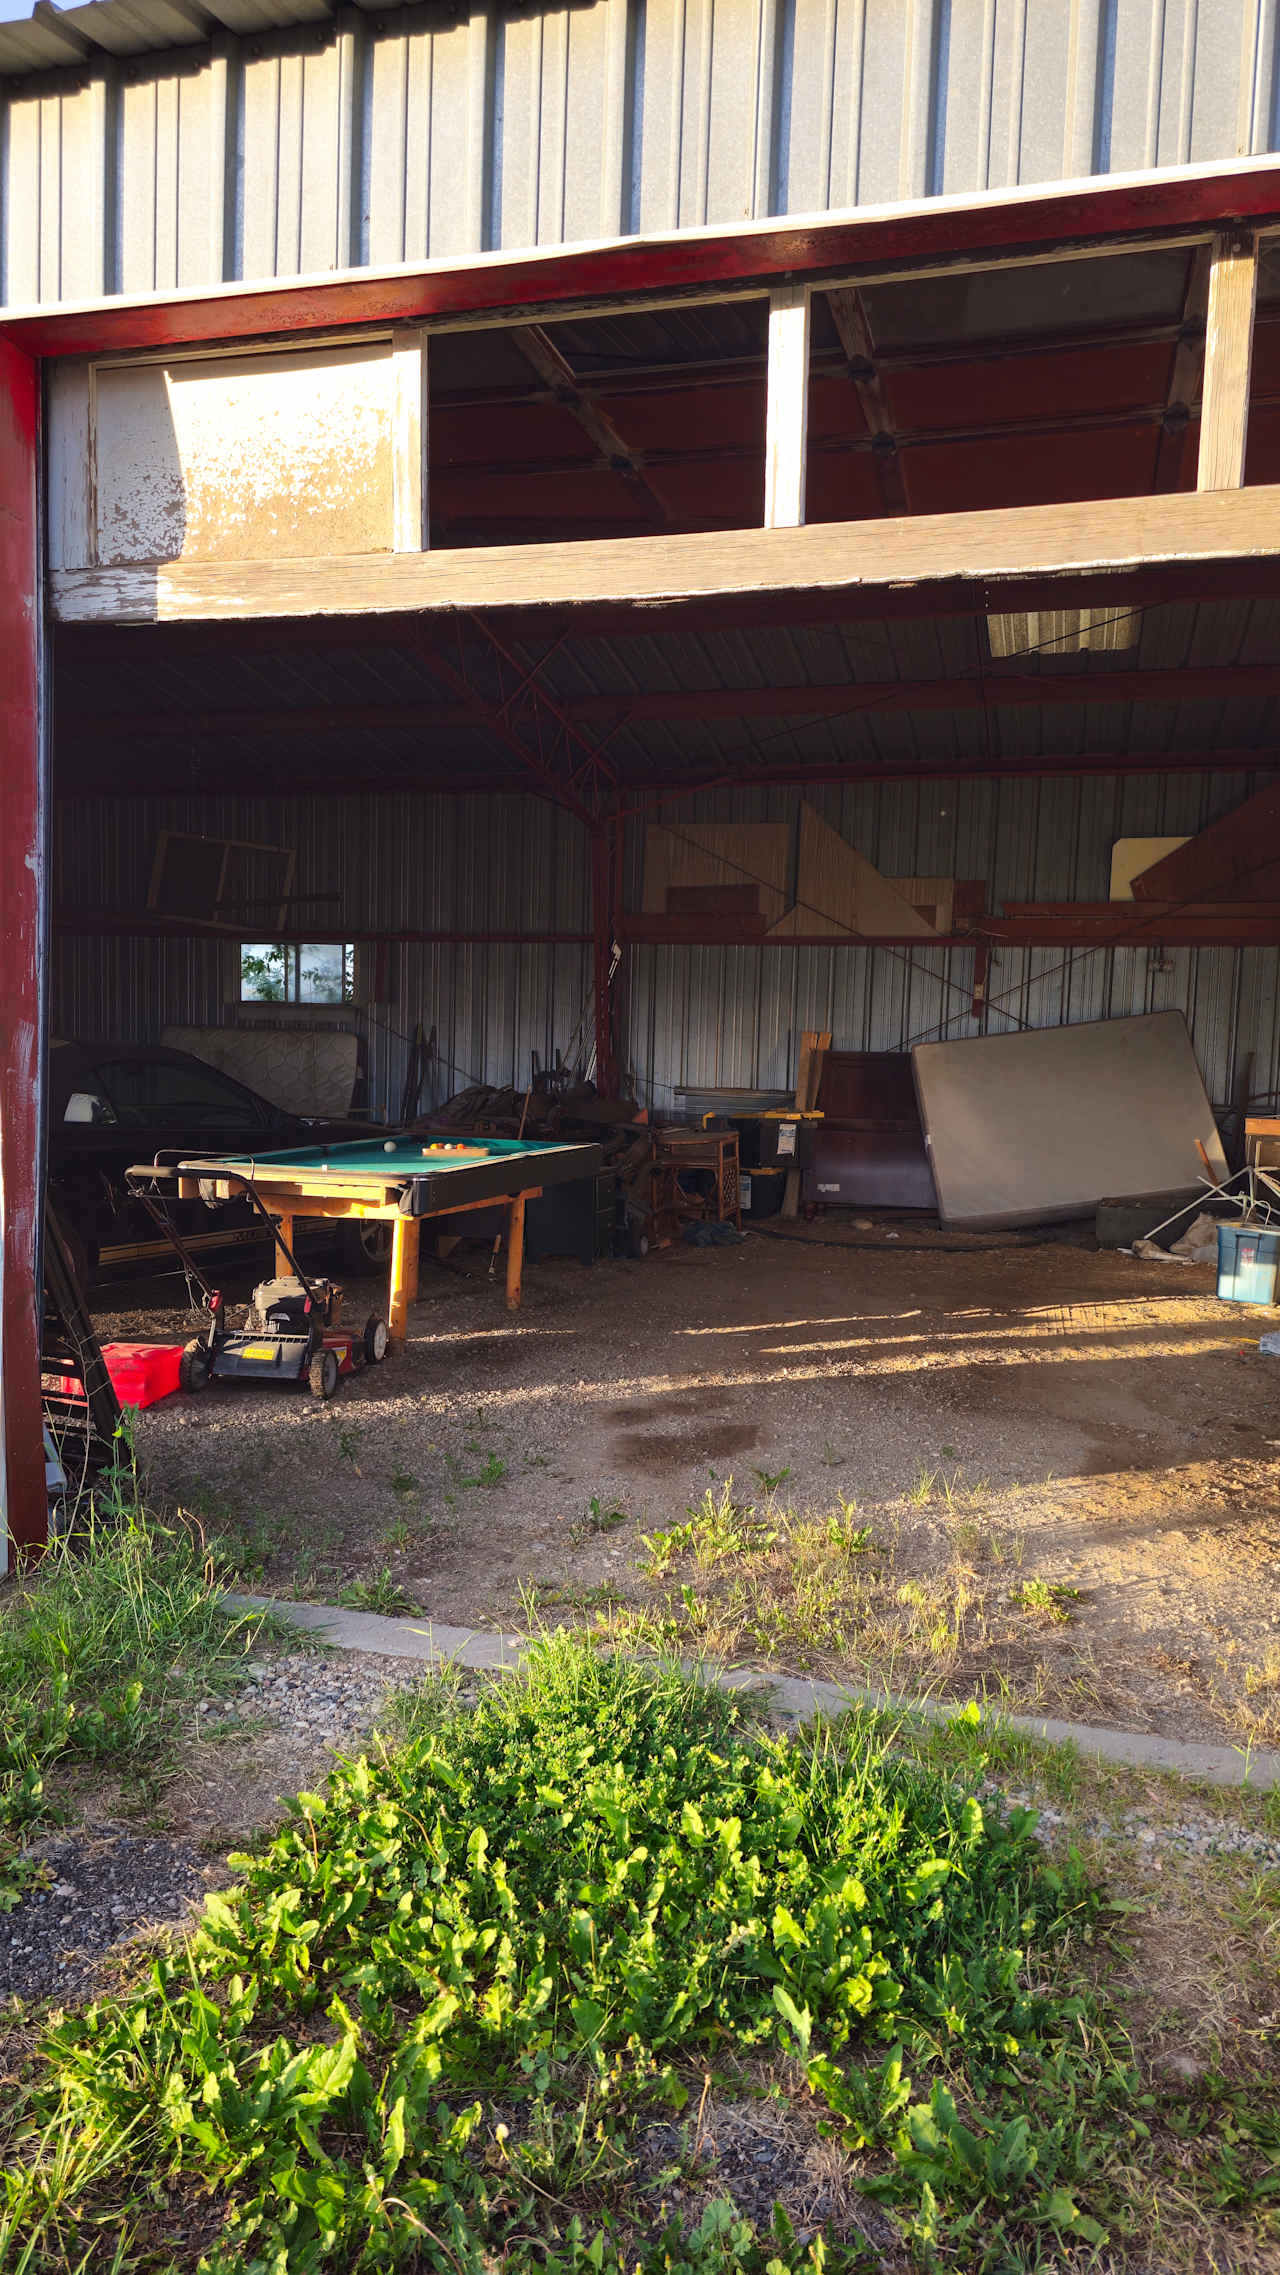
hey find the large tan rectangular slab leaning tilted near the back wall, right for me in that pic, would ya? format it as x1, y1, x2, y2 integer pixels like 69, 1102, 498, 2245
912, 1010, 1225, 1231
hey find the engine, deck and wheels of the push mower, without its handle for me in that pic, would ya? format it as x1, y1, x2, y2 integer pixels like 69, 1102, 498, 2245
180, 1276, 387, 1399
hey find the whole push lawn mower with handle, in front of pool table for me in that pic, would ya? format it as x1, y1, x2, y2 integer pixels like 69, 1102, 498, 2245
127, 1160, 389, 1399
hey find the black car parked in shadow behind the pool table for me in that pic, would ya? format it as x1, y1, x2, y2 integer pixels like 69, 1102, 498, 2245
48, 1042, 391, 1279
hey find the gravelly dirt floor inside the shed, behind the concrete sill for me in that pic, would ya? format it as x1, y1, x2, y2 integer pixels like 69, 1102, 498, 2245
95, 1215, 1280, 1743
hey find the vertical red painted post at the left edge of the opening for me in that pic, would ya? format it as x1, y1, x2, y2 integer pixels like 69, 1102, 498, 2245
0, 339, 48, 1547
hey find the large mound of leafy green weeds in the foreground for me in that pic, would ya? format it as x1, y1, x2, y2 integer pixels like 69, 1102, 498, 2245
0, 1638, 1144, 2275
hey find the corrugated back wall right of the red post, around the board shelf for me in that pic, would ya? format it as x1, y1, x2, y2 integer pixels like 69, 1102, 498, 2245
613, 774, 1280, 1112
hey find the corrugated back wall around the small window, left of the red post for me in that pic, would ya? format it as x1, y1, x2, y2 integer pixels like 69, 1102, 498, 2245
52, 796, 591, 1117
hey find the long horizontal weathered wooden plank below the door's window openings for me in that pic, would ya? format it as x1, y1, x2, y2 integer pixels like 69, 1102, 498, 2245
50, 485, 1280, 623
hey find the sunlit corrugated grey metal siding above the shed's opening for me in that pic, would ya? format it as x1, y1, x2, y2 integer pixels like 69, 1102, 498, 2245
0, 0, 1278, 305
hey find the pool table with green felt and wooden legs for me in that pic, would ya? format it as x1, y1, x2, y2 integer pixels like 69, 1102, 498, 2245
177, 1135, 602, 1345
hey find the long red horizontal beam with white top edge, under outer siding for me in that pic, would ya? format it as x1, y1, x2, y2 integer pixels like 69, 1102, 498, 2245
0, 159, 1280, 355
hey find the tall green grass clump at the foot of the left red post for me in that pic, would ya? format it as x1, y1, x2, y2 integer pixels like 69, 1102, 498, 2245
0, 1436, 264, 1911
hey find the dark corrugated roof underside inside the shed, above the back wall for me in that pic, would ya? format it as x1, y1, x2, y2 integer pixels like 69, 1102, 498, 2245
55, 598, 1280, 805
